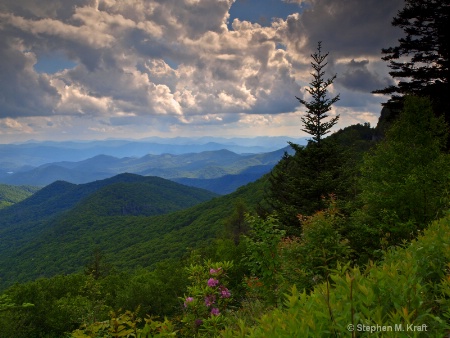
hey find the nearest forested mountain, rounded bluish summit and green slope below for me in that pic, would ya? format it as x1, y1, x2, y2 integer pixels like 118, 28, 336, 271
0, 174, 262, 288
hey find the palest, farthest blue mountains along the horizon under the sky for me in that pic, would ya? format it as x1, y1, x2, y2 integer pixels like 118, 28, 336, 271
0, 137, 306, 167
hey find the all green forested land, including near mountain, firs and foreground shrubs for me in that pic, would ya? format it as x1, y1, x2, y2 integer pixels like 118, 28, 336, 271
0, 0, 450, 338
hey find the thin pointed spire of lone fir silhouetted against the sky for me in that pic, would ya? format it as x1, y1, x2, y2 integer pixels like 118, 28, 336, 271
297, 42, 339, 143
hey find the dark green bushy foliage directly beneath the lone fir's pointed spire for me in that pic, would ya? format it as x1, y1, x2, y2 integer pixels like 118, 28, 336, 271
267, 138, 355, 232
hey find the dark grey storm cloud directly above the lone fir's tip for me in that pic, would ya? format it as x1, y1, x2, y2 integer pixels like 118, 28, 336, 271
301, 0, 404, 57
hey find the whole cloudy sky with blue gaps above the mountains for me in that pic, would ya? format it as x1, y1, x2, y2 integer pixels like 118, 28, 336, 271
0, 0, 404, 143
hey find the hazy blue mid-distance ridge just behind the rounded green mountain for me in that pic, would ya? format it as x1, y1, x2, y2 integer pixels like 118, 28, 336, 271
0, 147, 292, 194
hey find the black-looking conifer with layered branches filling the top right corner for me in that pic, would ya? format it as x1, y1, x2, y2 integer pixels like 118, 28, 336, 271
373, 0, 450, 122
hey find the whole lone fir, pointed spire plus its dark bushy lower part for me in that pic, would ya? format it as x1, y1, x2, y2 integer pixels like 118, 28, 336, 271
268, 42, 346, 235
